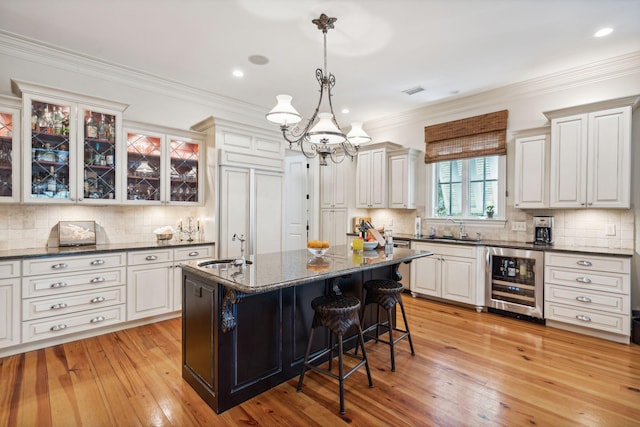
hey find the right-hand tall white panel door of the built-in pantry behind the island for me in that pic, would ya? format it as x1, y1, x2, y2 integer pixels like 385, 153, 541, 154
251, 170, 284, 254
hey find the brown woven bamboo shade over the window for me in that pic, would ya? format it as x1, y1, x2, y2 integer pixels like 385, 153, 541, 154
424, 110, 509, 163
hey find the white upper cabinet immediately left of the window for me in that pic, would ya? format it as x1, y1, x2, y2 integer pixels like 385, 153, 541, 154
388, 149, 424, 209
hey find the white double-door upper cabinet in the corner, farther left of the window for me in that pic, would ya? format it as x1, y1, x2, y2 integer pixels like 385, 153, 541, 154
356, 148, 388, 209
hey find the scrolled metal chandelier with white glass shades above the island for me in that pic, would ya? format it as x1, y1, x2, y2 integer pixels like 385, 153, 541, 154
266, 13, 371, 166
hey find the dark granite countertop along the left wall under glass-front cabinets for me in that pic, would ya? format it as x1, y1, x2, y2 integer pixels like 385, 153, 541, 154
0, 240, 215, 261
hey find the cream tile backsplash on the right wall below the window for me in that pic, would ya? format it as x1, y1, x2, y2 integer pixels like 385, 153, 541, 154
362, 209, 634, 249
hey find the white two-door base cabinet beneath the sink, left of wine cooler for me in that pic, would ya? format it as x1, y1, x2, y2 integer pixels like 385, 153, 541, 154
411, 242, 484, 311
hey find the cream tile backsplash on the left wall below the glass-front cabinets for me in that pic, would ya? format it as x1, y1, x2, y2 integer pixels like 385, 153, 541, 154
0, 205, 205, 250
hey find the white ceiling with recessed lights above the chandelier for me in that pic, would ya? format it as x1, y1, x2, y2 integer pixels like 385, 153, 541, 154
0, 0, 640, 128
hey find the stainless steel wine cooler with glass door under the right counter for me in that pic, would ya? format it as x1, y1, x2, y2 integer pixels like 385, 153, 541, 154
485, 247, 544, 321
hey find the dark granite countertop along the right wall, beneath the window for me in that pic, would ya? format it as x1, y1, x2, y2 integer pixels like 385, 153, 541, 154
347, 233, 633, 256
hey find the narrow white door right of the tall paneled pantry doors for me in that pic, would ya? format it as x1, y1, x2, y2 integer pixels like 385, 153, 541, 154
284, 155, 310, 251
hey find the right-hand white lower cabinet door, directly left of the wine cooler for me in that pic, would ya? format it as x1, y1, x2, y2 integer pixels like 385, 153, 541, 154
442, 257, 476, 304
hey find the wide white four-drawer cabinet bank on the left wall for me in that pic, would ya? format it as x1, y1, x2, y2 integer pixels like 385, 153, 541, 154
21, 252, 127, 343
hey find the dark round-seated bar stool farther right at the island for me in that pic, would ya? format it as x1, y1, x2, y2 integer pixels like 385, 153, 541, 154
355, 279, 416, 372
